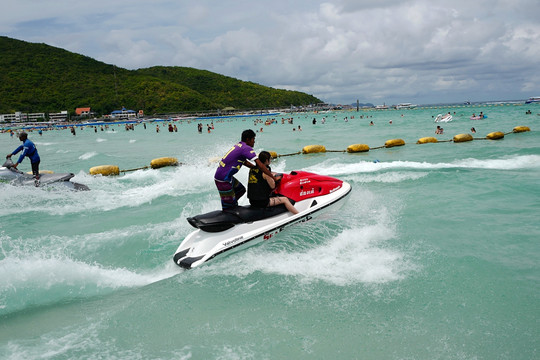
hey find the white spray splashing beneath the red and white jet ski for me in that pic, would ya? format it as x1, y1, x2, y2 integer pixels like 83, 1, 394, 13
196, 190, 415, 286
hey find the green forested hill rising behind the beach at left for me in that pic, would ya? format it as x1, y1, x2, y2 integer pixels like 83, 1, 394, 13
0, 36, 321, 114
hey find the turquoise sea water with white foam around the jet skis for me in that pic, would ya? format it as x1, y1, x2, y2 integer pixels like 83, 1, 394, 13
0, 104, 540, 359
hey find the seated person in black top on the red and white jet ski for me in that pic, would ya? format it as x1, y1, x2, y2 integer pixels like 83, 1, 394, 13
248, 151, 298, 214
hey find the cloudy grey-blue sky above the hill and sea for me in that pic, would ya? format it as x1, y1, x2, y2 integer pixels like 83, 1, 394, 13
0, 0, 540, 104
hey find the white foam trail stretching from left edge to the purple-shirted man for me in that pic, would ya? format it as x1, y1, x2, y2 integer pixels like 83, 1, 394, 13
0, 166, 215, 216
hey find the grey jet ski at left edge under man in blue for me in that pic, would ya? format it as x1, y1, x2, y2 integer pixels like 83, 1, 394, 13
0, 159, 90, 190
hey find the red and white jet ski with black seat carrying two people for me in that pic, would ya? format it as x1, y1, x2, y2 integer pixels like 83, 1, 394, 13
173, 171, 351, 269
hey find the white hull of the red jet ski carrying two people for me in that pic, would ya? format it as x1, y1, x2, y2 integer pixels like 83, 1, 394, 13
173, 174, 351, 269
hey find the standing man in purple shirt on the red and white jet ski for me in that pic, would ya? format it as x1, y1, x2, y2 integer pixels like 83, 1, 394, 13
214, 129, 277, 210
